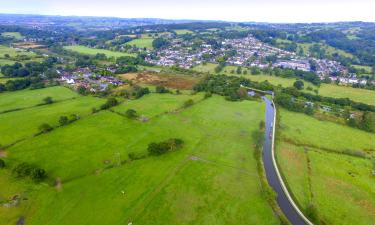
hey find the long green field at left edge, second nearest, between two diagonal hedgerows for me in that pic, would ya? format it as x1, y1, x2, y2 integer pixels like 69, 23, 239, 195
0, 97, 104, 146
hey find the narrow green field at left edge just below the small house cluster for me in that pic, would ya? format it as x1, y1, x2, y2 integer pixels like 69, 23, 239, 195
0, 86, 78, 112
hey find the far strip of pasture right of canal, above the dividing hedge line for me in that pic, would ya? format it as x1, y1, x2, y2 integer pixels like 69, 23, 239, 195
279, 110, 375, 155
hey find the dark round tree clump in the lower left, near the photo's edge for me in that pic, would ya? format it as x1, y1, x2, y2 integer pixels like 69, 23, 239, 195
12, 163, 47, 182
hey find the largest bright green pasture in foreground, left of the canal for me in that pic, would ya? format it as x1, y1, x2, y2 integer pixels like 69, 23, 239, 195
0, 96, 280, 225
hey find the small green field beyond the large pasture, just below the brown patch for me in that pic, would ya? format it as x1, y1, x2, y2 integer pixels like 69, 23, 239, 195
113, 93, 203, 118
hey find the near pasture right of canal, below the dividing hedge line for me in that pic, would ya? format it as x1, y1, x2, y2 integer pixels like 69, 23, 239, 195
277, 142, 375, 225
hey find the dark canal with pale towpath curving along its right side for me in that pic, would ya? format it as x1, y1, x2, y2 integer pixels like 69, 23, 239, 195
263, 96, 312, 225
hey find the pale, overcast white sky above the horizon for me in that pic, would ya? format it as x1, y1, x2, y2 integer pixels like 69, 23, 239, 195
0, 0, 375, 23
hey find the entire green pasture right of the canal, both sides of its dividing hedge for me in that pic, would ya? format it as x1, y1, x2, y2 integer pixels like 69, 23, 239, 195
276, 110, 375, 225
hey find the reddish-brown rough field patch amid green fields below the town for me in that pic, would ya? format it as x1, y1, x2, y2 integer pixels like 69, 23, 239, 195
120, 73, 197, 90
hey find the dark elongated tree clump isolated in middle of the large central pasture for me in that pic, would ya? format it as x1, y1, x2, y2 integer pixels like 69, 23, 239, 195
147, 138, 184, 155
